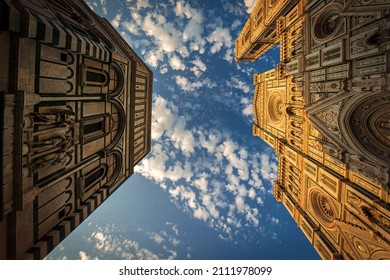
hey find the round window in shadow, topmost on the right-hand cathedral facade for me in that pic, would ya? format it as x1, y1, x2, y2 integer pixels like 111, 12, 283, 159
313, 4, 342, 42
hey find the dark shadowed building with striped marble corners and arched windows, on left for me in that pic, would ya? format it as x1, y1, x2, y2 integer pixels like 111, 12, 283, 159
0, 0, 153, 259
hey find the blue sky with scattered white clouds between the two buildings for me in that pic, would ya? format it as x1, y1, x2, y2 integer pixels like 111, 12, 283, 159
47, 0, 319, 260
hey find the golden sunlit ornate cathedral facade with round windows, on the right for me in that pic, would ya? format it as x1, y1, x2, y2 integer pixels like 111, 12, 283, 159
235, 0, 390, 259
